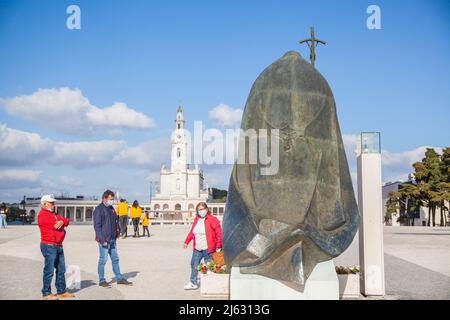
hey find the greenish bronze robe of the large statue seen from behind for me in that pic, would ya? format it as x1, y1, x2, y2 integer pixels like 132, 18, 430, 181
223, 51, 359, 290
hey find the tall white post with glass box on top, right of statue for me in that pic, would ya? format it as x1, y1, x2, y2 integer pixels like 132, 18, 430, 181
357, 133, 385, 296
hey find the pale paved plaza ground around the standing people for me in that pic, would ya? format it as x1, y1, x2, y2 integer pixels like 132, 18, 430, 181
0, 225, 450, 300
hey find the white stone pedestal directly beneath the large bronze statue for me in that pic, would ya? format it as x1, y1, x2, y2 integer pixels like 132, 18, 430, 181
230, 260, 339, 300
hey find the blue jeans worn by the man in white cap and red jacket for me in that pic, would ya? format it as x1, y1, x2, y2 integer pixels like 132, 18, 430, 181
41, 244, 67, 296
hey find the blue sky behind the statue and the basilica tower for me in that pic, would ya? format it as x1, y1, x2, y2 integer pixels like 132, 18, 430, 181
0, 0, 450, 201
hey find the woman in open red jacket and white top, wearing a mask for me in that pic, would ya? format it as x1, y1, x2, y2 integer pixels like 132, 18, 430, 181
183, 202, 222, 290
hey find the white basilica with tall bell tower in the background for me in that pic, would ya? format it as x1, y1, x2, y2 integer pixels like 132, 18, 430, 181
151, 107, 210, 212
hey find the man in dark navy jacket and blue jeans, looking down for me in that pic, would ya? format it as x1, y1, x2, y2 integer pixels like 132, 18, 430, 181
93, 190, 132, 288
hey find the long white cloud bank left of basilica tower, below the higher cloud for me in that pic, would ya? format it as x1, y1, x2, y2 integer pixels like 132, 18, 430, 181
0, 124, 170, 168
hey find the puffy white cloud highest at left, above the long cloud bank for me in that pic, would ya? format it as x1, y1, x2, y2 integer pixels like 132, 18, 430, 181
0, 87, 154, 135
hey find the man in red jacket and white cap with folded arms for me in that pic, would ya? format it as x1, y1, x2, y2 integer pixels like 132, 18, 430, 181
38, 194, 75, 300
